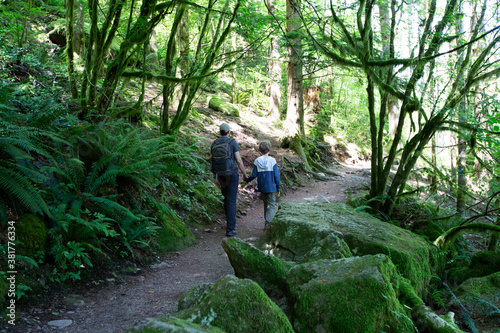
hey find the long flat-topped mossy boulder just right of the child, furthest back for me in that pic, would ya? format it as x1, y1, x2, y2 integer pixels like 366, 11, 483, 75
270, 203, 441, 296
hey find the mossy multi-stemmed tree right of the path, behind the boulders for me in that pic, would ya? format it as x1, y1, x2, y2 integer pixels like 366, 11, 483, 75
301, 0, 500, 213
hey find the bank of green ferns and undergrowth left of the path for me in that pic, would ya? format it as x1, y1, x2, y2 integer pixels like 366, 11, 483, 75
0, 113, 221, 303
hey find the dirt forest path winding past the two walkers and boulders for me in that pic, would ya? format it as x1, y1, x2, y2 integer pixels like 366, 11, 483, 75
8, 164, 369, 333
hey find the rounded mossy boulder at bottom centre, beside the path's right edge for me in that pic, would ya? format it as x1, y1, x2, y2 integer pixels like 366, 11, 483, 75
174, 275, 293, 333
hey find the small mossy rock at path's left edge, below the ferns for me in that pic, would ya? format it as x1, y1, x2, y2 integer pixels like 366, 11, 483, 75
156, 205, 195, 253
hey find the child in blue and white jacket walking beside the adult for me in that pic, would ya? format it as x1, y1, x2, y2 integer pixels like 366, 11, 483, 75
244, 141, 280, 228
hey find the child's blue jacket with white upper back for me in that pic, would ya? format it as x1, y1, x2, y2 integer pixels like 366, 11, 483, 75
244, 155, 280, 193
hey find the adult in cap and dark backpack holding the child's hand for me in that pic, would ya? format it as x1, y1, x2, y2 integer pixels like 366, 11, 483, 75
210, 123, 247, 237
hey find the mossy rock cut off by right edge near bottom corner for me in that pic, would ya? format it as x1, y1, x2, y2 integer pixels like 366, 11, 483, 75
451, 272, 500, 320
